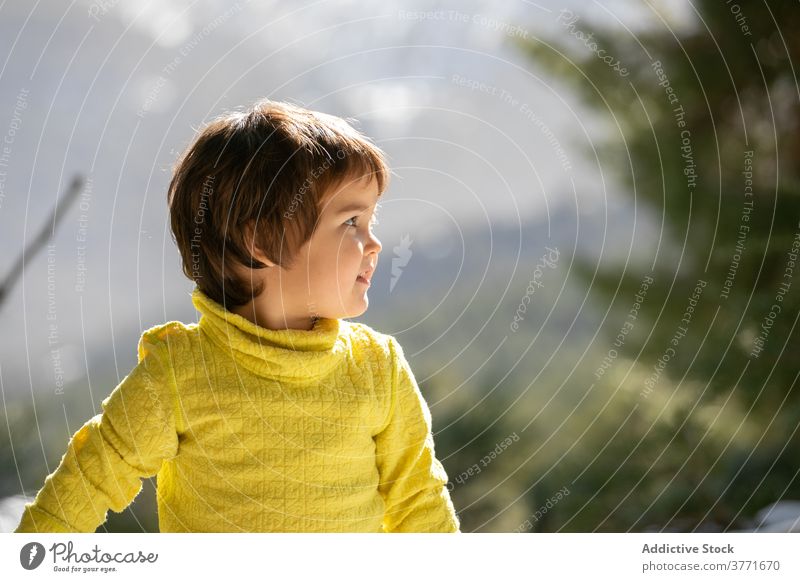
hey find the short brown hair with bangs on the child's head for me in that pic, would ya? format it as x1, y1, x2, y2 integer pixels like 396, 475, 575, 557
167, 100, 390, 308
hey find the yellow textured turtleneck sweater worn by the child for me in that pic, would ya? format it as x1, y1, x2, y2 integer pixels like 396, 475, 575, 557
16, 289, 459, 532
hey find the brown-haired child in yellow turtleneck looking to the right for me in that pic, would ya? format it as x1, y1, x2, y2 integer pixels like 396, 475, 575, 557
16, 101, 460, 532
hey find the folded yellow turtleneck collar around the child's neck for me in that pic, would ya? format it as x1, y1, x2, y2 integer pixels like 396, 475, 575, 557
192, 288, 348, 379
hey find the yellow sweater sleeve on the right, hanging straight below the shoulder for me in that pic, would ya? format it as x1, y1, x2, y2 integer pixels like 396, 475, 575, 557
374, 338, 460, 533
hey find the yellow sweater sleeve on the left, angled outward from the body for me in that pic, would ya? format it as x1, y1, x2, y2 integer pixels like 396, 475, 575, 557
15, 332, 178, 533
